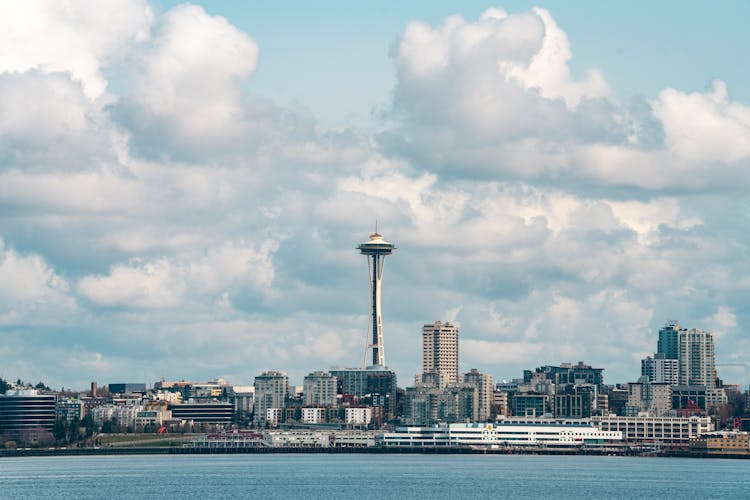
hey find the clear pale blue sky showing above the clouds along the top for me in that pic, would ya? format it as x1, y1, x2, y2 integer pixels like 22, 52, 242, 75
147, 0, 750, 126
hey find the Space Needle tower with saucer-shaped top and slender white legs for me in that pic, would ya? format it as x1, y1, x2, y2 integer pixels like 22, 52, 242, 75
357, 226, 396, 366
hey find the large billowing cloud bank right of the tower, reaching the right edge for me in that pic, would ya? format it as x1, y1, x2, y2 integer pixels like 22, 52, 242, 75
379, 8, 750, 190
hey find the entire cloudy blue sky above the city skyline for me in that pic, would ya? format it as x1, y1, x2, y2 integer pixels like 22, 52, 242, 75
0, 0, 750, 388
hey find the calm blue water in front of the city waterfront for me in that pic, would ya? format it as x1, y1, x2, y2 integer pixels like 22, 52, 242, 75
0, 454, 750, 500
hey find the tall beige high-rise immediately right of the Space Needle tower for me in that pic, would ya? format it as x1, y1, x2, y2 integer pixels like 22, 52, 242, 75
422, 321, 459, 385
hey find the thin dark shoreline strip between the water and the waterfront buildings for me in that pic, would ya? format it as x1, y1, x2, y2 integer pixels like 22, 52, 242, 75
0, 447, 750, 460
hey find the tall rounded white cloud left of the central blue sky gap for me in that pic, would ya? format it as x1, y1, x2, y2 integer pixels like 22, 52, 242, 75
117, 4, 263, 156
